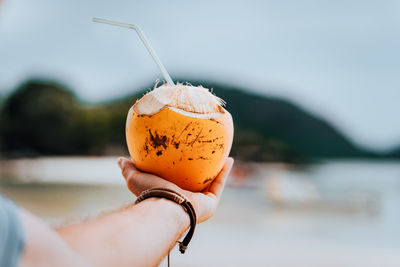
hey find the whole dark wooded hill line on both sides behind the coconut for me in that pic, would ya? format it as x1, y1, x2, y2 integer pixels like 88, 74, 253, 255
0, 80, 378, 162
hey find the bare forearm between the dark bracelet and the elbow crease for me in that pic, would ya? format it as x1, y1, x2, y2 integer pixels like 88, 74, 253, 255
58, 198, 189, 266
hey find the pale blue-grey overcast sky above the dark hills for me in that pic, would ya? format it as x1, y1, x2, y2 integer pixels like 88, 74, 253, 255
0, 0, 400, 151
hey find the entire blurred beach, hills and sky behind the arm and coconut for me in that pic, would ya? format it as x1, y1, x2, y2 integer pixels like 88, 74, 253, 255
0, 0, 400, 266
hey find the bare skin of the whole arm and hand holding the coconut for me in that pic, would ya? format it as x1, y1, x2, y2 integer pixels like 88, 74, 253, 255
20, 158, 233, 266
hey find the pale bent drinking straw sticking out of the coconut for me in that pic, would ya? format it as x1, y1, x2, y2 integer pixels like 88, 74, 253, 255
93, 18, 175, 86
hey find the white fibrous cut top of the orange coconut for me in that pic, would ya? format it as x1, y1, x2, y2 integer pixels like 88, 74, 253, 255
133, 84, 225, 118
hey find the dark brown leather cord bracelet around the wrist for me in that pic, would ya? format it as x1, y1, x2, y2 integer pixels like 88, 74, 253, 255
135, 188, 197, 254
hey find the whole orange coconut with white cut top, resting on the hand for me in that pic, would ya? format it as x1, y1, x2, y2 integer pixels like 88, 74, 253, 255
126, 84, 233, 192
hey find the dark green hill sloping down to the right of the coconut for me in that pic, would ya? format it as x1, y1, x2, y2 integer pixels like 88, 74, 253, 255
186, 80, 376, 161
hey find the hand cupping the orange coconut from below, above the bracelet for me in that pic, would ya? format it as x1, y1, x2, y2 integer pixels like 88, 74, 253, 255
118, 157, 233, 223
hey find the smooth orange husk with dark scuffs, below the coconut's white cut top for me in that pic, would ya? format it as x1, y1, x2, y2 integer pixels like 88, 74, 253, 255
126, 108, 233, 192
